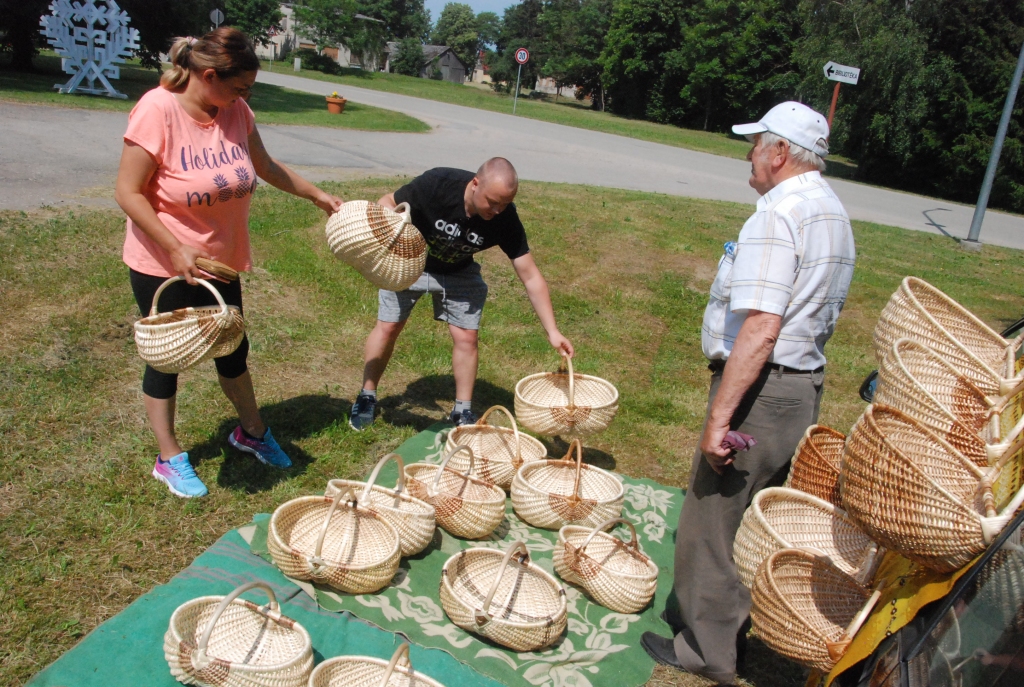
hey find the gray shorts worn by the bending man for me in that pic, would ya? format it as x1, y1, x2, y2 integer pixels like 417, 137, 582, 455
377, 262, 487, 330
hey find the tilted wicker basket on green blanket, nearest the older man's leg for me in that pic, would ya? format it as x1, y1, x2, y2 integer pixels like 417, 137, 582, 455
553, 518, 657, 613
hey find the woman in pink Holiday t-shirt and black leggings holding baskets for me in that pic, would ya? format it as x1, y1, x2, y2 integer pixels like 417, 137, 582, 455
115, 28, 342, 497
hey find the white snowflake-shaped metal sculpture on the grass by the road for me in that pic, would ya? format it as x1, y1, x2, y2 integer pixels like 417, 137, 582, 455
39, 0, 138, 98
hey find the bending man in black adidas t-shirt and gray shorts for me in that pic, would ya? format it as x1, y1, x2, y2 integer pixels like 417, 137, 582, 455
349, 158, 573, 430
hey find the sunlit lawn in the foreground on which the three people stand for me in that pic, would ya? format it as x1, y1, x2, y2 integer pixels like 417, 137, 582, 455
0, 179, 1024, 687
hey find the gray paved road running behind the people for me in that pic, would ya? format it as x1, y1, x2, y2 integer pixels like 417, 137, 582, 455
0, 72, 1024, 249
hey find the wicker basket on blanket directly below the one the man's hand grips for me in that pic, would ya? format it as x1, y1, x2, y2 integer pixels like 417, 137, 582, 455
512, 439, 625, 529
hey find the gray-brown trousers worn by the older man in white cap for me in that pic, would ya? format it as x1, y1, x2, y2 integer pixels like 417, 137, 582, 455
667, 369, 824, 684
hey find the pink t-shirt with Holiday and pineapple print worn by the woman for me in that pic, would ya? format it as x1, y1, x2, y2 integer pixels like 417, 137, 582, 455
124, 87, 256, 276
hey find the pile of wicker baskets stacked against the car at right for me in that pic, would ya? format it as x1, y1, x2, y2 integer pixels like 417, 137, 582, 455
733, 277, 1024, 673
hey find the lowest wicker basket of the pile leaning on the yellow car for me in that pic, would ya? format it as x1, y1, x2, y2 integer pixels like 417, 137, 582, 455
751, 549, 881, 673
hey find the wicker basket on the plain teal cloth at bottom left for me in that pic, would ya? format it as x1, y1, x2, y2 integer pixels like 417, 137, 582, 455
164, 582, 313, 687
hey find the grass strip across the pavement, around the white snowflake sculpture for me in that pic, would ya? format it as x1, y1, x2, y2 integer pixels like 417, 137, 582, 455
0, 54, 430, 133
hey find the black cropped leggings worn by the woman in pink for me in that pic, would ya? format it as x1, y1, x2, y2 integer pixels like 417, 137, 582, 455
128, 268, 249, 398
